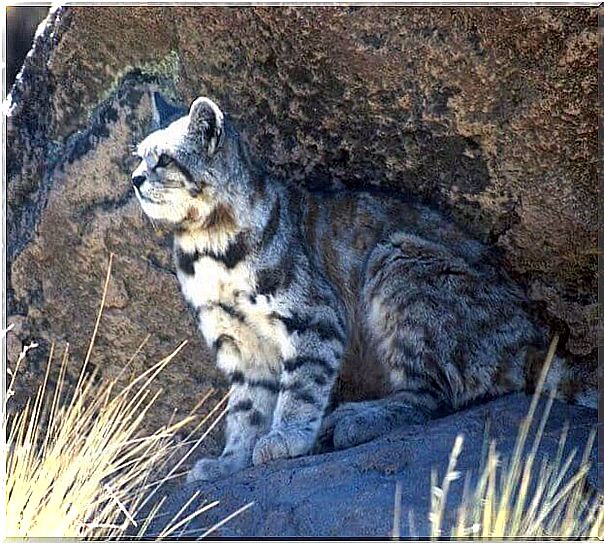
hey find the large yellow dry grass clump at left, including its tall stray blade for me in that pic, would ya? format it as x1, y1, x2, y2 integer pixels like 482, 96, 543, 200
2, 260, 245, 539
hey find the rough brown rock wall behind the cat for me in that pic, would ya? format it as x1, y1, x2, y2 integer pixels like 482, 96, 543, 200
7, 6, 597, 450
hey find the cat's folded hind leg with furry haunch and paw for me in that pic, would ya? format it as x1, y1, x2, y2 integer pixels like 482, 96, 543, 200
322, 233, 536, 448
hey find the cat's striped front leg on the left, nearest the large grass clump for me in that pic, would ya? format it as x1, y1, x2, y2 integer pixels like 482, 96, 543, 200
188, 372, 278, 481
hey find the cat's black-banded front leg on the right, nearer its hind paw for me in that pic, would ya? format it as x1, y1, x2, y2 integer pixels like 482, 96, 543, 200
253, 308, 344, 465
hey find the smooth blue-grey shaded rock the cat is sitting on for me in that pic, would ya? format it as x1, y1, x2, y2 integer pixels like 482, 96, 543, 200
149, 394, 597, 539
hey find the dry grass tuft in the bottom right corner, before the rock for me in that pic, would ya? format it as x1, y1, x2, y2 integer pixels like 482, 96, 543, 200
430, 337, 604, 540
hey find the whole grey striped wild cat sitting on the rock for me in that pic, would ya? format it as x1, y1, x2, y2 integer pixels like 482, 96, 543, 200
133, 98, 587, 480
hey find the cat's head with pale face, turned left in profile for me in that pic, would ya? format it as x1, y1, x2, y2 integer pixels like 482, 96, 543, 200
132, 93, 231, 225
